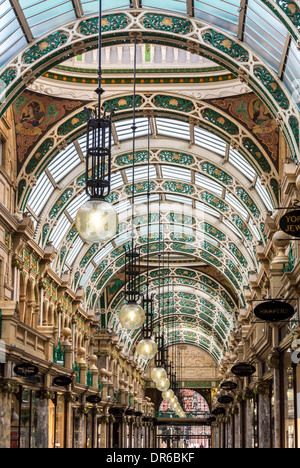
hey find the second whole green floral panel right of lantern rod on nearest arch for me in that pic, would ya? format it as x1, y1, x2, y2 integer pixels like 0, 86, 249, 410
203, 29, 249, 62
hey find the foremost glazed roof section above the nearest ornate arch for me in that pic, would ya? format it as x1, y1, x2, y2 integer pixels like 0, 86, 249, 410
0, 0, 300, 111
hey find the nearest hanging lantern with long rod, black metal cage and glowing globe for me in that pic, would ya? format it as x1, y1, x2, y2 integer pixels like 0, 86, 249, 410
75, 0, 119, 243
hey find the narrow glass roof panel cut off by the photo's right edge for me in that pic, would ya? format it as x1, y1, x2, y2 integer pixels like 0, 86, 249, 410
283, 40, 300, 109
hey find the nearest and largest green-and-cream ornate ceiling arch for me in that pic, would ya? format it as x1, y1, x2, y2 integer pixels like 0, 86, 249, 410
0, 10, 299, 158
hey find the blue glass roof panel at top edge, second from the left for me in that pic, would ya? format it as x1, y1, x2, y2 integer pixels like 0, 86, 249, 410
19, 0, 76, 38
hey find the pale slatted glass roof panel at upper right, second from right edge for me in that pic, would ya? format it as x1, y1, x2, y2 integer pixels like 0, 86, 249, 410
244, 0, 287, 72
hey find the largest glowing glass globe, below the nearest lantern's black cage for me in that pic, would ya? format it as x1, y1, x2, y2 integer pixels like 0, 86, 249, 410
75, 200, 119, 243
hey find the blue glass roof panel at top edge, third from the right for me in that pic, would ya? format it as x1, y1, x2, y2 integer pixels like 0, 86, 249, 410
194, 0, 241, 35
